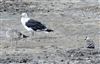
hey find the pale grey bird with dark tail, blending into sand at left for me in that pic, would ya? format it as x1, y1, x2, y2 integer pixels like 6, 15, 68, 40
6, 29, 28, 47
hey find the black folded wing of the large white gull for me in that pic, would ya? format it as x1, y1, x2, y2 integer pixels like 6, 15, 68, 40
26, 19, 46, 31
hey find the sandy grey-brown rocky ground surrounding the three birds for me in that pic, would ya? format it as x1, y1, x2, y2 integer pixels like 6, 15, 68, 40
0, 0, 100, 64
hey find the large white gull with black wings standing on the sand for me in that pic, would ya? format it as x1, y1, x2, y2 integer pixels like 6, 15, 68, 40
21, 13, 53, 35
